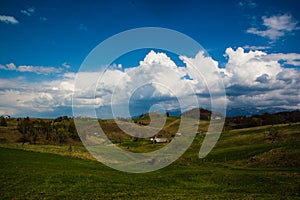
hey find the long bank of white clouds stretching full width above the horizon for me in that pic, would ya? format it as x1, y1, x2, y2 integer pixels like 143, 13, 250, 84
0, 47, 300, 115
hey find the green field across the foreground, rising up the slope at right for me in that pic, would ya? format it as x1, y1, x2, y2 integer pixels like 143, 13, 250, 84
0, 119, 300, 199
